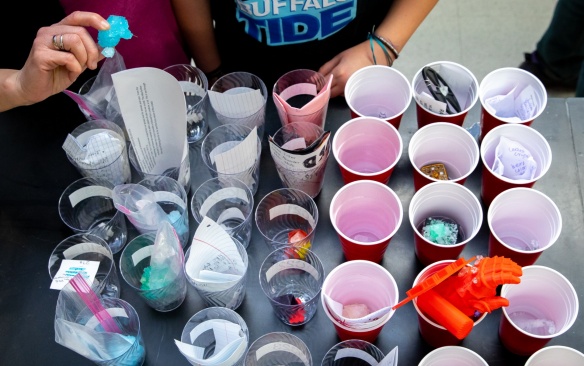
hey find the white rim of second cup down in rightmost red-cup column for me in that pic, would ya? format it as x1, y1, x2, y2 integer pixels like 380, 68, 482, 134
480, 123, 553, 185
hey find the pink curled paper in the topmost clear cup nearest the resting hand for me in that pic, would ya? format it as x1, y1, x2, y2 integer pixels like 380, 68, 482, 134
272, 75, 333, 127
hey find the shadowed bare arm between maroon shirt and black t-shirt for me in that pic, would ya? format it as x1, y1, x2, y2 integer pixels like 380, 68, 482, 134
171, 0, 221, 80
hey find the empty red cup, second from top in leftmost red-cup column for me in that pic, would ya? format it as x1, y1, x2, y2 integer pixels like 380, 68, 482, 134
332, 117, 403, 184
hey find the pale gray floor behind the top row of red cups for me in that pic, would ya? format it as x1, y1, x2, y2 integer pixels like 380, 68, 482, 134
394, 0, 574, 97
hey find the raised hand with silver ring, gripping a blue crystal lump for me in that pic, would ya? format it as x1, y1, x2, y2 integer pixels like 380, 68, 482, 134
0, 12, 109, 112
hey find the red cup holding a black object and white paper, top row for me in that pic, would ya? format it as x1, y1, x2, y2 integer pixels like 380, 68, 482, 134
412, 61, 479, 128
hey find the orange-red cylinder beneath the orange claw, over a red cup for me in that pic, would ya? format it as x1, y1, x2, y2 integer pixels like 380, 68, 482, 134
417, 290, 474, 339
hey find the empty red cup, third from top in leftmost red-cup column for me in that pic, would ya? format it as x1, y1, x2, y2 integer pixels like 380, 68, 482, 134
330, 180, 403, 262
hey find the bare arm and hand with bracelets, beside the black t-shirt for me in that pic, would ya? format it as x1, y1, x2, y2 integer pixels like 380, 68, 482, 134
318, 0, 438, 97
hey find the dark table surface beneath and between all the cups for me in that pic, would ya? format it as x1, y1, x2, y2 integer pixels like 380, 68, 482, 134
0, 94, 584, 366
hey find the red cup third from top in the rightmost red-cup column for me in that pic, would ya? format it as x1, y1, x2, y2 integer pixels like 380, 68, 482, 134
487, 187, 562, 266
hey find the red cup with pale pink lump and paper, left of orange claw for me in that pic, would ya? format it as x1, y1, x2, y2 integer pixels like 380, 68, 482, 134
320, 260, 399, 343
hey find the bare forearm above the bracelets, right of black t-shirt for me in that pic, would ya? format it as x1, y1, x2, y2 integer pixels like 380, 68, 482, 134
375, 0, 438, 52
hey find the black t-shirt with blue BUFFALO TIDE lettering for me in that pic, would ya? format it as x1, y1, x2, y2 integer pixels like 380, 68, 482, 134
211, 0, 392, 90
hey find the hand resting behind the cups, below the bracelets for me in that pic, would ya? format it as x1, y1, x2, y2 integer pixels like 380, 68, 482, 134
318, 41, 374, 98
